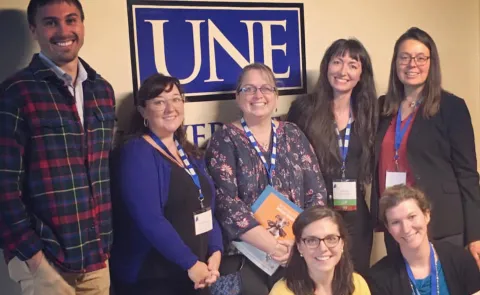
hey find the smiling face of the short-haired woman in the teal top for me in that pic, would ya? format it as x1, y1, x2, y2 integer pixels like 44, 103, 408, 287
385, 199, 430, 250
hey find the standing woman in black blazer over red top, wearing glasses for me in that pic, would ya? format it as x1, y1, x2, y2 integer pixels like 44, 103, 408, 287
371, 28, 480, 267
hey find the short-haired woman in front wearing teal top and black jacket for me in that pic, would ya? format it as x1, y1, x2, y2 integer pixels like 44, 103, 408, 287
366, 185, 480, 295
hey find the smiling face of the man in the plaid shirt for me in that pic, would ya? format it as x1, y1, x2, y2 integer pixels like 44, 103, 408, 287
30, 2, 84, 67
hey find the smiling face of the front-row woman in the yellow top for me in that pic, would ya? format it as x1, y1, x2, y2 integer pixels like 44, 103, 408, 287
297, 217, 344, 273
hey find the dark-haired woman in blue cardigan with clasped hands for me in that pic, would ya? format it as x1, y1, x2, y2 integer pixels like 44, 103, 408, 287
110, 74, 222, 295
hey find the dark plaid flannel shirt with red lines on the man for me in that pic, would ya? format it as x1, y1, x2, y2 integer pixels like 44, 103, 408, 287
0, 54, 115, 272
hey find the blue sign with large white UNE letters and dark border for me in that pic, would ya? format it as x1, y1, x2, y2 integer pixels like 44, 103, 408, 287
128, 0, 306, 101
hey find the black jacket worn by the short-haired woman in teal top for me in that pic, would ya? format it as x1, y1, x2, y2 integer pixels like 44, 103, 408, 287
365, 242, 480, 295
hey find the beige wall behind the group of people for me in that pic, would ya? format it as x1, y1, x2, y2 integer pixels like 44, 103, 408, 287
0, 0, 480, 295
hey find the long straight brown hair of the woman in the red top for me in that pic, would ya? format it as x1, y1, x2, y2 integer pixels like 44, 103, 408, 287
382, 27, 442, 118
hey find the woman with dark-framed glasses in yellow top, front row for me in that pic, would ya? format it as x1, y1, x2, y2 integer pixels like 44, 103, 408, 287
270, 206, 370, 295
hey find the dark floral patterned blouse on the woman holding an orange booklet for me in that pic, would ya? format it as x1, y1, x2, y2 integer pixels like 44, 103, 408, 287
206, 121, 327, 252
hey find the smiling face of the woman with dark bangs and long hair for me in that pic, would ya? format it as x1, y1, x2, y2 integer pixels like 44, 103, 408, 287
327, 52, 362, 95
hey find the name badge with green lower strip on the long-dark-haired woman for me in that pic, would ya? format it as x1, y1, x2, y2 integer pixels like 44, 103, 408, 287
333, 179, 357, 211
